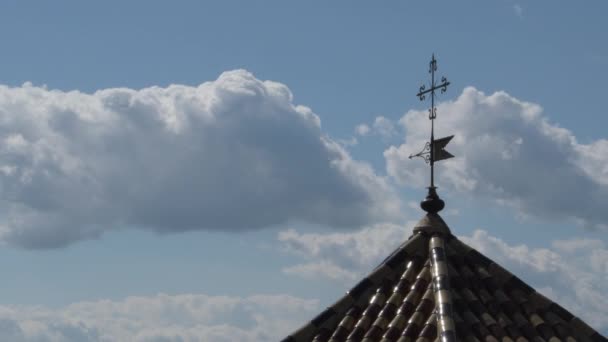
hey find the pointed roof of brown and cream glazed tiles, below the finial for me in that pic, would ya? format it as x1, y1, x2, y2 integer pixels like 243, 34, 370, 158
283, 214, 608, 342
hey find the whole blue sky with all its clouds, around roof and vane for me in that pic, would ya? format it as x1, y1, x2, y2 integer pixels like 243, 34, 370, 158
0, 0, 608, 341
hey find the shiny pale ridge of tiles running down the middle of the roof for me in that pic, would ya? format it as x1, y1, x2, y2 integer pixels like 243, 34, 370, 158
429, 234, 457, 342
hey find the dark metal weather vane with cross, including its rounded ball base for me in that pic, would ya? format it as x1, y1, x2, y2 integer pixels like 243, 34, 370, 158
410, 54, 454, 213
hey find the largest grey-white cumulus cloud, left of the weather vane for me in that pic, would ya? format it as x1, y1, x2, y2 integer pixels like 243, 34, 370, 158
0, 70, 399, 248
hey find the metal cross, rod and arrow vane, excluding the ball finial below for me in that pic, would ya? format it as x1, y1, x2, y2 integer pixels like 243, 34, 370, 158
410, 54, 454, 189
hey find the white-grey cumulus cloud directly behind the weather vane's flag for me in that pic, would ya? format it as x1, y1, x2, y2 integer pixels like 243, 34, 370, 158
384, 87, 608, 229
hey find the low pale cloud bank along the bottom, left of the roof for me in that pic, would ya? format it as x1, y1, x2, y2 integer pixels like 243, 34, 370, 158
0, 294, 320, 342
